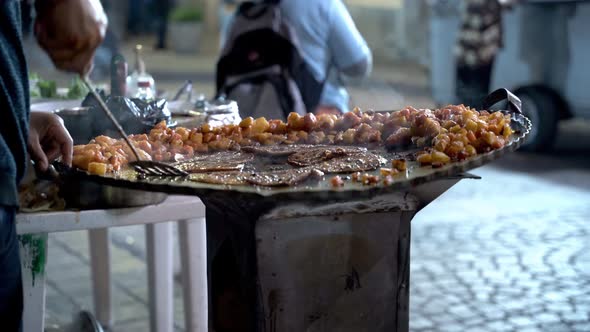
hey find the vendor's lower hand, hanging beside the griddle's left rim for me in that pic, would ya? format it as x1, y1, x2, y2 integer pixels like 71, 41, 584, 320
27, 112, 74, 171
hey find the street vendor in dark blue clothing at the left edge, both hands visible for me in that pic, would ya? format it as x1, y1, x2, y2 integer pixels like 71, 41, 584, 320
0, 0, 107, 331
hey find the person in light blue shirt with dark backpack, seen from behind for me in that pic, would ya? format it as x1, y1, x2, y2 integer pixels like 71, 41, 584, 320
217, 0, 372, 119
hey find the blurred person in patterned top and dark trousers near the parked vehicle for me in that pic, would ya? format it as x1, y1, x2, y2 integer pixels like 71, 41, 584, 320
455, 0, 518, 108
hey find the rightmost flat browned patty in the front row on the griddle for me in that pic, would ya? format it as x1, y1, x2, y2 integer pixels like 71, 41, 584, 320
314, 152, 386, 173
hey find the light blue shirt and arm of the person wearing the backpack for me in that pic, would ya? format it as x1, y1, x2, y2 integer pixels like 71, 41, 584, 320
221, 0, 373, 114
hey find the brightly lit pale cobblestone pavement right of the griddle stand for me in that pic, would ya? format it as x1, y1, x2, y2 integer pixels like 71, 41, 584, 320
410, 134, 590, 332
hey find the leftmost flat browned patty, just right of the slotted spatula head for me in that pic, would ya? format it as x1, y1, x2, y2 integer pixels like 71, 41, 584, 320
174, 151, 254, 173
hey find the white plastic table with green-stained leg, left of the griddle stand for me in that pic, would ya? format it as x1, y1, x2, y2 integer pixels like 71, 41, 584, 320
16, 196, 208, 332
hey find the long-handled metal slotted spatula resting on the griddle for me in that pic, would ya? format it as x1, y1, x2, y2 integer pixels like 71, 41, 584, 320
81, 76, 188, 176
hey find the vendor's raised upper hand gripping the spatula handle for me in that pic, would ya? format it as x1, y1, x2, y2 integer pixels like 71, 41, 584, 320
35, 0, 107, 76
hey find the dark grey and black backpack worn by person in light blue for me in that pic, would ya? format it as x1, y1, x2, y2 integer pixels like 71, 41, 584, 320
216, 0, 325, 120
